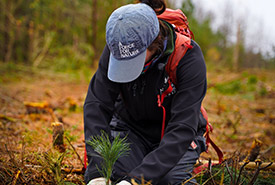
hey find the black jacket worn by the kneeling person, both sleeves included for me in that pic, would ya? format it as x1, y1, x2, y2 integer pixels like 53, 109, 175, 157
84, 30, 207, 184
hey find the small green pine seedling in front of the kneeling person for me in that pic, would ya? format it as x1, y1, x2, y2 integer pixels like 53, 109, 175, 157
87, 131, 130, 185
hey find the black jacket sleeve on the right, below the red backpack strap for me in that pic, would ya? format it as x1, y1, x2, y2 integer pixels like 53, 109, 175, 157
130, 41, 207, 184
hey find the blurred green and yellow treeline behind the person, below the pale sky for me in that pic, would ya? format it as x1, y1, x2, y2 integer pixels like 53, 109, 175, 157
0, 0, 275, 71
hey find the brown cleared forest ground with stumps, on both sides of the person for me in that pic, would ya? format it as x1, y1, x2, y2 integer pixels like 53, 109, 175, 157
0, 66, 275, 184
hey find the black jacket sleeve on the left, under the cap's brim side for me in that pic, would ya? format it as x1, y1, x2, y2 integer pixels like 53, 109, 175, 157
84, 46, 119, 183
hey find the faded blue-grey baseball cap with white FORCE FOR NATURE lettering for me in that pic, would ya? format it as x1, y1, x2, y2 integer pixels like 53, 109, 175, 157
106, 3, 159, 83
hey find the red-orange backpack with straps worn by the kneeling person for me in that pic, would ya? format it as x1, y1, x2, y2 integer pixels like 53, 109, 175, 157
158, 8, 223, 163
